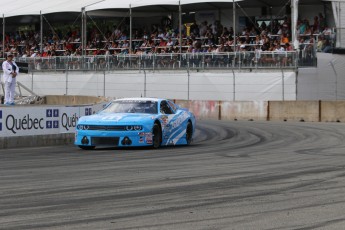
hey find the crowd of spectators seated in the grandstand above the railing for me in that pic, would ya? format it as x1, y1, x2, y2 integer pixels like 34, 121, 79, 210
0, 13, 332, 57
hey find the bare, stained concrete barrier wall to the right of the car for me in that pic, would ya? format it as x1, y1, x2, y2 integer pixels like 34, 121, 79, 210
175, 100, 345, 122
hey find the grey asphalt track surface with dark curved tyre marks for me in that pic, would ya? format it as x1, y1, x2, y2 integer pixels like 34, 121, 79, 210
0, 121, 345, 230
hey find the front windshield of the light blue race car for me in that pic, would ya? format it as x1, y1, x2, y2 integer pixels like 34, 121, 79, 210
102, 101, 158, 114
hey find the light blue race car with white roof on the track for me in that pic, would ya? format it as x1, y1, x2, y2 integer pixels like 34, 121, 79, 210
74, 98, 195, 149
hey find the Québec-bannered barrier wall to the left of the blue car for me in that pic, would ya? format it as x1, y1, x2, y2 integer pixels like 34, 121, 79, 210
0, 99, 107, 148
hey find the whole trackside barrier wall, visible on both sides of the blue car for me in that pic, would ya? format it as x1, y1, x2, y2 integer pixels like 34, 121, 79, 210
0, 99, 345, 148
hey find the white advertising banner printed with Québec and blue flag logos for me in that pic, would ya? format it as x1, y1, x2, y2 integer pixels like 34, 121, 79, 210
0, 103, 105, 137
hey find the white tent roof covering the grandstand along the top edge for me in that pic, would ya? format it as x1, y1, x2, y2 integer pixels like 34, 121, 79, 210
0, 0, 321, 17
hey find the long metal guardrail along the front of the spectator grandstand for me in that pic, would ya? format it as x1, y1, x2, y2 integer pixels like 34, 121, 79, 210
10, 51, 299, 72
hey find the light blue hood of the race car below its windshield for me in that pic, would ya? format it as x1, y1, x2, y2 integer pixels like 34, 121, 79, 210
78, 113, 157, 124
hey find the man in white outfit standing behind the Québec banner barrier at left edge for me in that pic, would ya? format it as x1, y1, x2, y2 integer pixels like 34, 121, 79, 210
2, 53, 19, 105
